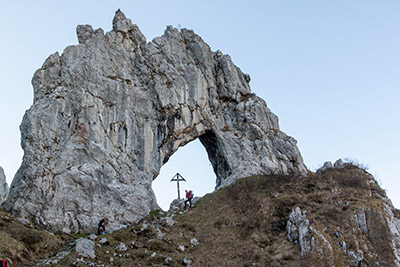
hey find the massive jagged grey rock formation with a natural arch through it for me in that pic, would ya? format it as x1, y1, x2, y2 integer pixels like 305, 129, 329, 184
5, 10, 306, 232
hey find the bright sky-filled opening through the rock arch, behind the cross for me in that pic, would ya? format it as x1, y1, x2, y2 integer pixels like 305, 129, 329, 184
152, 138, 216, 210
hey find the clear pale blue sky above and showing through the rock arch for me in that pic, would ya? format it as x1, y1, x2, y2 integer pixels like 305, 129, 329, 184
0, 0, 400, 211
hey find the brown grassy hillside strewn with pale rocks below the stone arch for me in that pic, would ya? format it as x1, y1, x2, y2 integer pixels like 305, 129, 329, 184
0, 164, 399, 266
